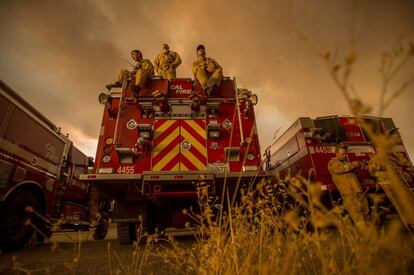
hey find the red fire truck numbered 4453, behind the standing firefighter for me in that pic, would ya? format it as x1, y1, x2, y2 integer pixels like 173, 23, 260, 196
265, 116, 414, 211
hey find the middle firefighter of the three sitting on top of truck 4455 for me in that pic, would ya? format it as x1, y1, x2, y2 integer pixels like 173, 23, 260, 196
154, 43, 181, 80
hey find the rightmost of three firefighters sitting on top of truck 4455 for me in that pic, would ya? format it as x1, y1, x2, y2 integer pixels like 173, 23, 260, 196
193, 45, 223, 95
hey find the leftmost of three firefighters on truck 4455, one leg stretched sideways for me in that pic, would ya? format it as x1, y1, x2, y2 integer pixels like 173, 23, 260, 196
106, 50, 154, 95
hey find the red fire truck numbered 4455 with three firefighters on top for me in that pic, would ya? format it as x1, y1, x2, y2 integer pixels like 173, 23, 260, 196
81, 78, 264, 243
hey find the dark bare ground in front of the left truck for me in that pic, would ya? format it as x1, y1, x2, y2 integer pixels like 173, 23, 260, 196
0, 224, 194, 274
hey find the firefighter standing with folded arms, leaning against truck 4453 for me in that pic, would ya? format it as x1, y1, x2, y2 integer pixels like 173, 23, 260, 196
328, 145, 369, 229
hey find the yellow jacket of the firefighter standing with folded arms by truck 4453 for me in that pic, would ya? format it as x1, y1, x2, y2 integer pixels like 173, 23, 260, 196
328, 157, 362, 195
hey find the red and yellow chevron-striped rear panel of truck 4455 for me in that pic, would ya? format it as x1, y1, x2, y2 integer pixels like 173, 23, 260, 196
152, 119, 207, 171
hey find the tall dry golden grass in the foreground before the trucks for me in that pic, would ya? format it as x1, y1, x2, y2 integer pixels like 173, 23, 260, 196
102, 178, 414, 274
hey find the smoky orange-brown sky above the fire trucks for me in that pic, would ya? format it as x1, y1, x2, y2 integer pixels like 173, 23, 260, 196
0, 0, 414, 160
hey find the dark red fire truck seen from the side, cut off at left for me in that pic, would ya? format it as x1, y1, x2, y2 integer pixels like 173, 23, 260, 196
0, 81, 107, 250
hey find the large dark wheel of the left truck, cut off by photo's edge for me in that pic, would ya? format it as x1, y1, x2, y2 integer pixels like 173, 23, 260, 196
0, 191, 39, 250
